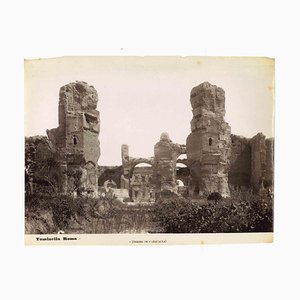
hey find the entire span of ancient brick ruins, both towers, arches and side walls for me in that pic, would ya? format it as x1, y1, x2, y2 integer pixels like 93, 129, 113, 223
25, 81, 274, 203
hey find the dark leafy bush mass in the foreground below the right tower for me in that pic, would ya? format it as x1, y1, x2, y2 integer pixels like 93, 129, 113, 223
154, 191, 273, 233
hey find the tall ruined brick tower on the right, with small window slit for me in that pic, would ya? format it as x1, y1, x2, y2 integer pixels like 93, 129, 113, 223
186, 82, 231, 197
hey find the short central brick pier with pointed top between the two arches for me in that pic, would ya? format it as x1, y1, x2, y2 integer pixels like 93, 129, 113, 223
153, 133, 186, 194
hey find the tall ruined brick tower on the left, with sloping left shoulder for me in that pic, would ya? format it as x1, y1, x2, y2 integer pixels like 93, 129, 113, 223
47, 81, 100, 195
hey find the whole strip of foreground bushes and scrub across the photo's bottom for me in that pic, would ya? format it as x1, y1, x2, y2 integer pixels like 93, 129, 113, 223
25, 191, 273, 234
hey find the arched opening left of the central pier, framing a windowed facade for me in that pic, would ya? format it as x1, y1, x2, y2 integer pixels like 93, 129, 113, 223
129, 163, 154, 202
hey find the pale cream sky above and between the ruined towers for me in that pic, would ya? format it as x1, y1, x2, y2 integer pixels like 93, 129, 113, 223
25, 56, 274, 165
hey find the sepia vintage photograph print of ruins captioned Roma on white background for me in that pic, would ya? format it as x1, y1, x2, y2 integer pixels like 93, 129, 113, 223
24, 56, 275, 244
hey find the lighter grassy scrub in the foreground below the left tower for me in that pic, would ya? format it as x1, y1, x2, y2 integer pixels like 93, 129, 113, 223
25, 194, 152, 234
